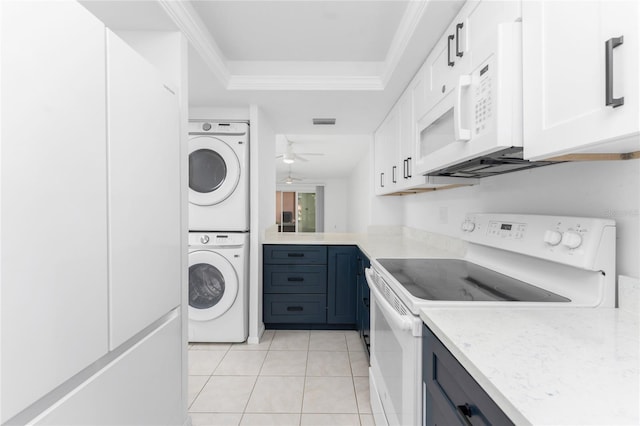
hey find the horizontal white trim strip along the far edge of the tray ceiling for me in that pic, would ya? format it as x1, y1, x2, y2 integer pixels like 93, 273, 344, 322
227, 75, 384, 91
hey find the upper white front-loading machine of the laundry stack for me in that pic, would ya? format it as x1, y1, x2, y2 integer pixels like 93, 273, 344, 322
189, 120, 249, 231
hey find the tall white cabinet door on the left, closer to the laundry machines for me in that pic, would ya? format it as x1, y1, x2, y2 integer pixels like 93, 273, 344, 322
107, 32, 181, 348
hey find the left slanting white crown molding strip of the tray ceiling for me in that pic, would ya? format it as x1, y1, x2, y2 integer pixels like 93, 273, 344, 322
158, 0, 231, 86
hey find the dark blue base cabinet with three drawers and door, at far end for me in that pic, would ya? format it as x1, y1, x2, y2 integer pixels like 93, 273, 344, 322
263, 244, 358, 329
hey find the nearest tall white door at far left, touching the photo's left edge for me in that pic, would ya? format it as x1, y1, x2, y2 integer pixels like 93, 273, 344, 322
0, 1, 108, 424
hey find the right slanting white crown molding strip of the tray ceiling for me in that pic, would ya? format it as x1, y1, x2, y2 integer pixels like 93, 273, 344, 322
379, 0, 429, 87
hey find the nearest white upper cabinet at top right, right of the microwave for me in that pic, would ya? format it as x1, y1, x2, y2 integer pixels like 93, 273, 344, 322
522, 0, 640, 159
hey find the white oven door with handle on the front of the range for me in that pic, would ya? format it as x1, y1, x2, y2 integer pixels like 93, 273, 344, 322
366, 269, 422, 426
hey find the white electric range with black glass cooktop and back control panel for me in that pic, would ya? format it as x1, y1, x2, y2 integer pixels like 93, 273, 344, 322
366, 213, 616, 425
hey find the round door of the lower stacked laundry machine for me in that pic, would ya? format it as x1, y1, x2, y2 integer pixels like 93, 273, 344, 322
189, 250, 239, 321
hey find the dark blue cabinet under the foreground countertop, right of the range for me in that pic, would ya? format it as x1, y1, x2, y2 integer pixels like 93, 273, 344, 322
422, 326, 513, 426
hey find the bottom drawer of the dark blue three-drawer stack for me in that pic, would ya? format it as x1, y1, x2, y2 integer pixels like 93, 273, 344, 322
263, 294, 327, 324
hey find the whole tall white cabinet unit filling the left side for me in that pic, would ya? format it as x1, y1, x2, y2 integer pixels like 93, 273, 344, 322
0, 1, 184, 425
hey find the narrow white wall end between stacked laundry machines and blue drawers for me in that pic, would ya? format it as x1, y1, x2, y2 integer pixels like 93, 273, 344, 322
248, 105, 276, 343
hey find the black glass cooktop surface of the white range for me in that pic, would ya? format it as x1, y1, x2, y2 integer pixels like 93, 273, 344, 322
378, 259, 571, 302
